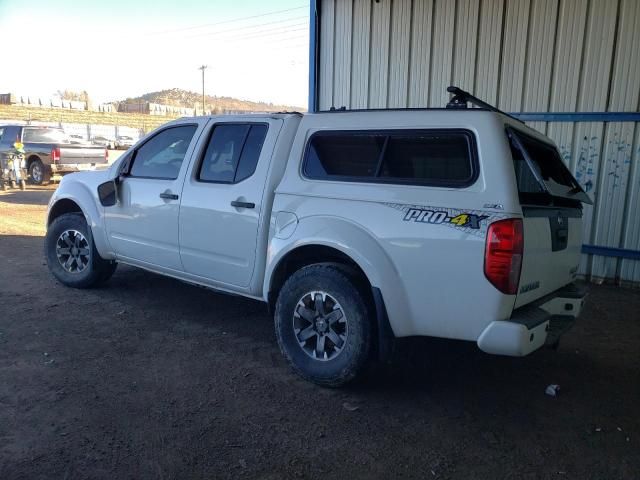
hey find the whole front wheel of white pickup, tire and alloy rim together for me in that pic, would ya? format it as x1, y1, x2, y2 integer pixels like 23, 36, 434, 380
45, 213, 117, 288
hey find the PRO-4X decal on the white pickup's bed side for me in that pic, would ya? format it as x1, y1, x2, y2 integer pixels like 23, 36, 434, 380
386, 203, 505, 236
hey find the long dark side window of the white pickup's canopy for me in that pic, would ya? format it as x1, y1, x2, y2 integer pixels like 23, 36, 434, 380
303, 130, 477, 187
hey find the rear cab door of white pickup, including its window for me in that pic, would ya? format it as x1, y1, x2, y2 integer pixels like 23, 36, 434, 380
179, 118, 283, 288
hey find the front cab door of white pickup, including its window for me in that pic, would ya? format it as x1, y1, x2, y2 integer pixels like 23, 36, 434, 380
105, 119, 207, 271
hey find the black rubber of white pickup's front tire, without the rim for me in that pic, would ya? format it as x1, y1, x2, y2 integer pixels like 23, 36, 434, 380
44, 213, 118, 288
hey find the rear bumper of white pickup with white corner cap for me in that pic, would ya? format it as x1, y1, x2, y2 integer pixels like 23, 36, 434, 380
478, 284, 587, 357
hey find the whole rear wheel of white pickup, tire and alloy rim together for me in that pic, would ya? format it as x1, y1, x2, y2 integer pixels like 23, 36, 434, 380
275, 264, 372, 387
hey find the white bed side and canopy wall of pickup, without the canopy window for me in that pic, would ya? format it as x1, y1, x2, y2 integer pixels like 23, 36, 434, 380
269, 111, 521, 340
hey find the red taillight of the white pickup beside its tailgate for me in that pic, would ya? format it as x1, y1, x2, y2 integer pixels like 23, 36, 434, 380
484, 218, 524, 295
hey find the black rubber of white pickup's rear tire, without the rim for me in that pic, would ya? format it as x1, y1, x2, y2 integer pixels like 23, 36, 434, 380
275, 264, 373, 387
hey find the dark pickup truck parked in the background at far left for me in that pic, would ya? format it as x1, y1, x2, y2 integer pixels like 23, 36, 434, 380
0, 125, 109, 185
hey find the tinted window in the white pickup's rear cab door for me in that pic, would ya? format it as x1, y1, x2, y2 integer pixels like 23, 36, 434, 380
197, 123, 267, 183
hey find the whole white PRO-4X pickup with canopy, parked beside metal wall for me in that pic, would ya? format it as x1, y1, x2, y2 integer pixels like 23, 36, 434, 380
46, 89, 590, 386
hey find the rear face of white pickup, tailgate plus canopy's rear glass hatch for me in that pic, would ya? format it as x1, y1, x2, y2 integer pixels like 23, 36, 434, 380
507, 128, 591, 308
